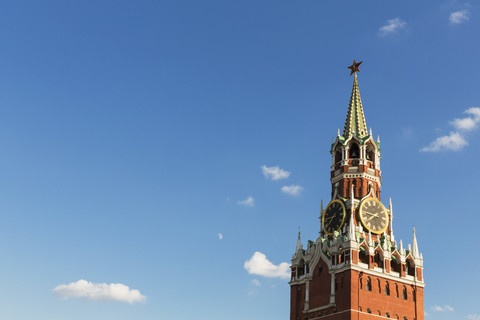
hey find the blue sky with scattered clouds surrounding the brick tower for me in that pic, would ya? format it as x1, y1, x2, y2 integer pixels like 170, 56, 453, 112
0, 0, 480, 320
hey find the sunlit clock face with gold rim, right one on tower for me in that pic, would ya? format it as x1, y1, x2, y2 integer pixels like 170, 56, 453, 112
360, 198, 388, 234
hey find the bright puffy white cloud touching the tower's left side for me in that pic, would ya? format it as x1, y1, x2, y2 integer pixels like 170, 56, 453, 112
243, 251, 290, 279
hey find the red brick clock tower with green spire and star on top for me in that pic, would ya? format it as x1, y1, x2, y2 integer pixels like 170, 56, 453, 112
290, 60, 425, 320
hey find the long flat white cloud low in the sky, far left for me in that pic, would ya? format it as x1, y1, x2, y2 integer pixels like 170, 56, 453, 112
53, 280, 147, 303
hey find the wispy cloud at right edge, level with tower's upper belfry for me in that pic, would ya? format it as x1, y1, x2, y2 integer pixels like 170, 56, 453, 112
420, 108, 480, 152
